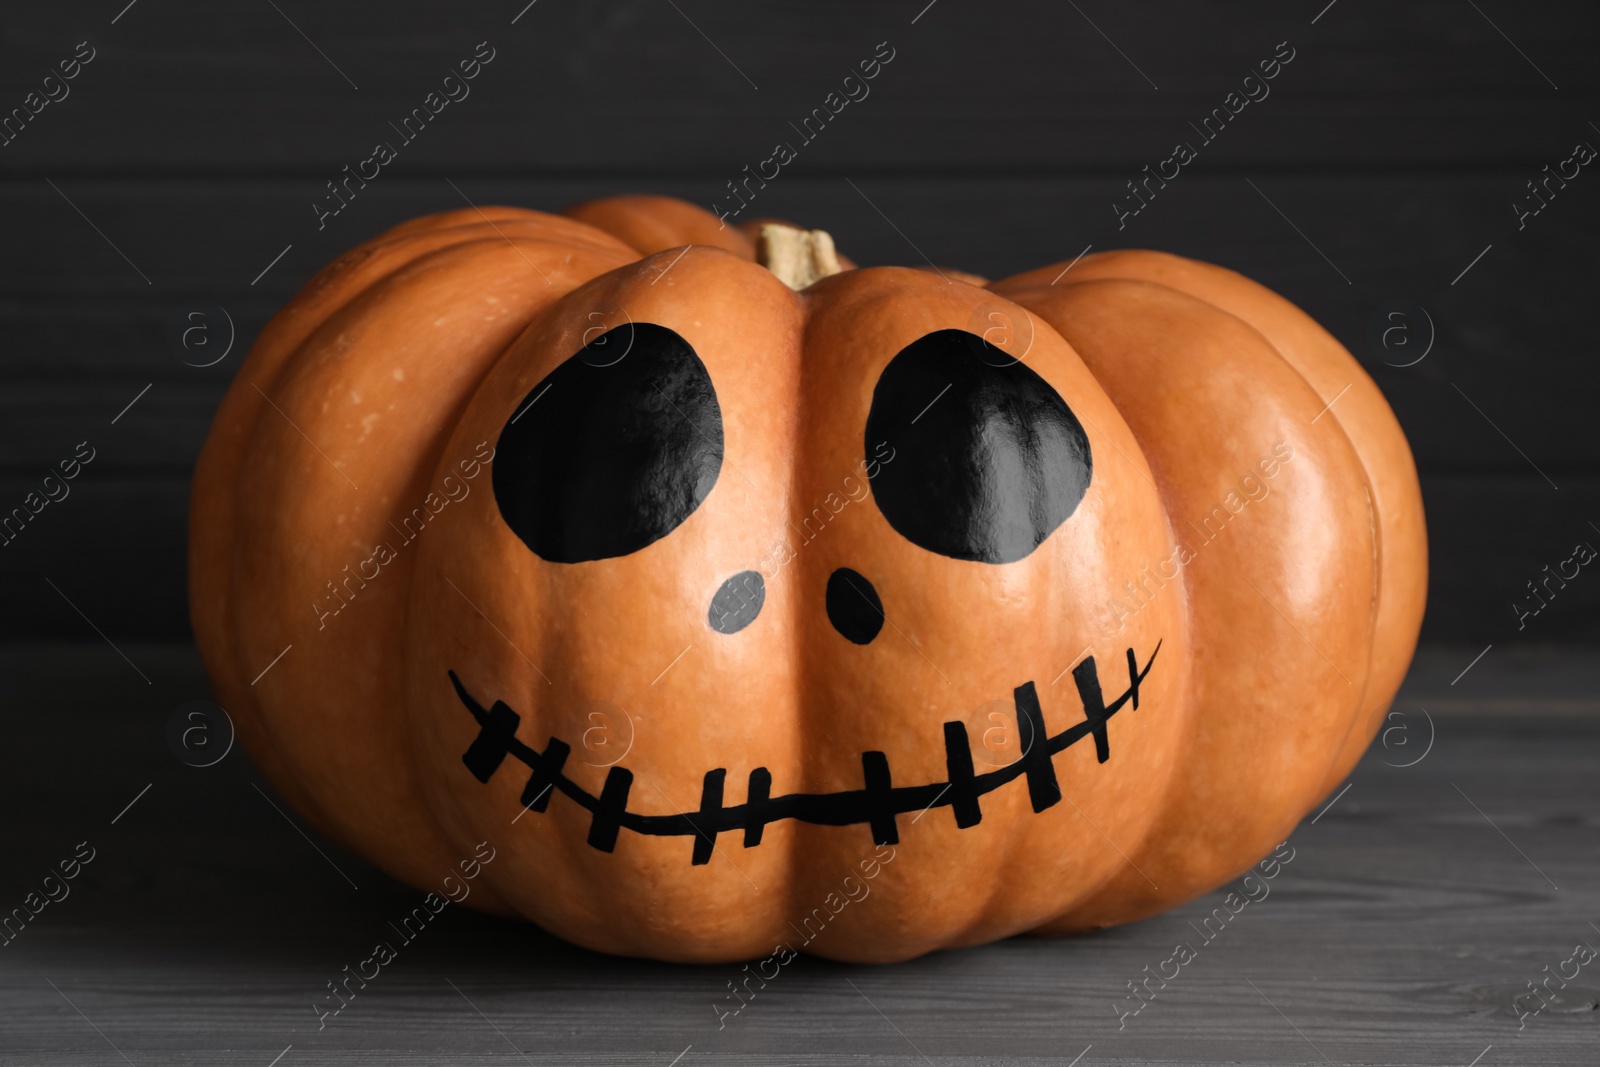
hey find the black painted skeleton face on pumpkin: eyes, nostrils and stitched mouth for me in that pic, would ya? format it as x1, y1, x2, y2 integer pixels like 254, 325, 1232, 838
464, 308, 1154, 864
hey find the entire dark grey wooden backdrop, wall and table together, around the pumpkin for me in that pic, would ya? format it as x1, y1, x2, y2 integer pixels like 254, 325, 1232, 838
0, 0, 1600, 1067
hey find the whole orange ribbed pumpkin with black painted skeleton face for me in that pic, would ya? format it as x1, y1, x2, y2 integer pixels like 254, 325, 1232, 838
190, 197, 1426, 961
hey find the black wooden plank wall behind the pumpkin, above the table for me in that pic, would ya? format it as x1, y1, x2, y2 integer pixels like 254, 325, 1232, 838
0, 0, 1600, 643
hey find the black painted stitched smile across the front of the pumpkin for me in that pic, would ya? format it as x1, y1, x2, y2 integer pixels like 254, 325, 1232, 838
450, 641, 1162, 865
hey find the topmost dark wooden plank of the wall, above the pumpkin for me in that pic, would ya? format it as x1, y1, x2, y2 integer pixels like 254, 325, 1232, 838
0, 0, 1595, 173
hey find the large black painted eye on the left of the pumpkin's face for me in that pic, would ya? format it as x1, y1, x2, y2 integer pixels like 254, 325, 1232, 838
493, 323, 722, 563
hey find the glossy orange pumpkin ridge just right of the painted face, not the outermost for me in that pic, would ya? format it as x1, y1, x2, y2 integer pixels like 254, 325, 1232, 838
997, 272, 1373, 931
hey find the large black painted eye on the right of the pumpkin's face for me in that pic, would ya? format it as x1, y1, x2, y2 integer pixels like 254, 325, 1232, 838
866, 330, 1093, 563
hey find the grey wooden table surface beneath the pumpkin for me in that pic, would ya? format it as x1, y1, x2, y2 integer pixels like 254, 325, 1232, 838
0, 645, 1600, 1067
